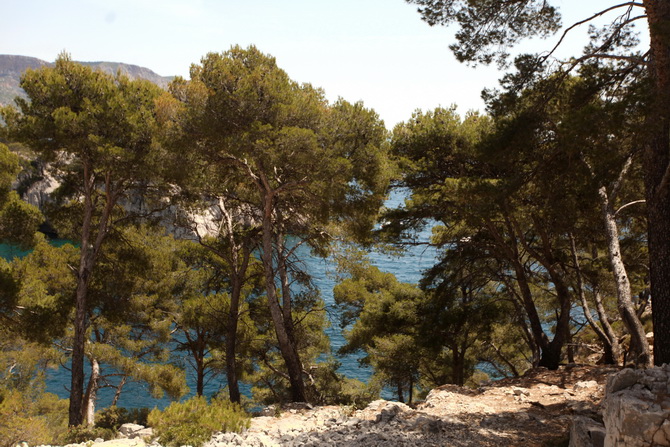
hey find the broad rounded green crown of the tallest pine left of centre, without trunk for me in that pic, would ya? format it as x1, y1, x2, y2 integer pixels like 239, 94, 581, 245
165, 47, 391, 249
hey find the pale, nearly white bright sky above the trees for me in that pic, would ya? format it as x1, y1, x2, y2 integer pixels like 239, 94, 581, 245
0, 0, 646, 129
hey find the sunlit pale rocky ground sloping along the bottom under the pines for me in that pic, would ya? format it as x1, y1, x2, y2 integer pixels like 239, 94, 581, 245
42, 365, 617, 447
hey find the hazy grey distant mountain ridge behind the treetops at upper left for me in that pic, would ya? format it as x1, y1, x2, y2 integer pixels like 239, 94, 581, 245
0, 54, 173, 105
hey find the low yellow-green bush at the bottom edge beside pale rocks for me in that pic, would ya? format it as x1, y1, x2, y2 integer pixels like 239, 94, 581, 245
148, 396, 249, 447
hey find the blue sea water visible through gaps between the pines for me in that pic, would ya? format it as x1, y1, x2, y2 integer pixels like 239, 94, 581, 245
0, 191, 436, 408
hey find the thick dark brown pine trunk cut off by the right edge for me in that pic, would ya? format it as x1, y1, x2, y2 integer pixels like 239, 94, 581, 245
643, 0, 670, 365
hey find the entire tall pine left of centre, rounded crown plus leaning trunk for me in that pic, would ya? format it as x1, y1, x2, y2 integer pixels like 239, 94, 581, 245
164, 46, 391, 401
